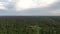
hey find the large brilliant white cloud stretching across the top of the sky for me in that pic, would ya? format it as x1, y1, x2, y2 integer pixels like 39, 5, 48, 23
15, 0, 57, 10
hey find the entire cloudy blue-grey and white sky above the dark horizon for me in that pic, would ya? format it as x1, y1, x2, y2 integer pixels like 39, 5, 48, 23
0, 0, 60, 16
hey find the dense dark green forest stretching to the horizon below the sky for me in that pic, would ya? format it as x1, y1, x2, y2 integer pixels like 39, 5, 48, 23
0, 16, 60, 34
